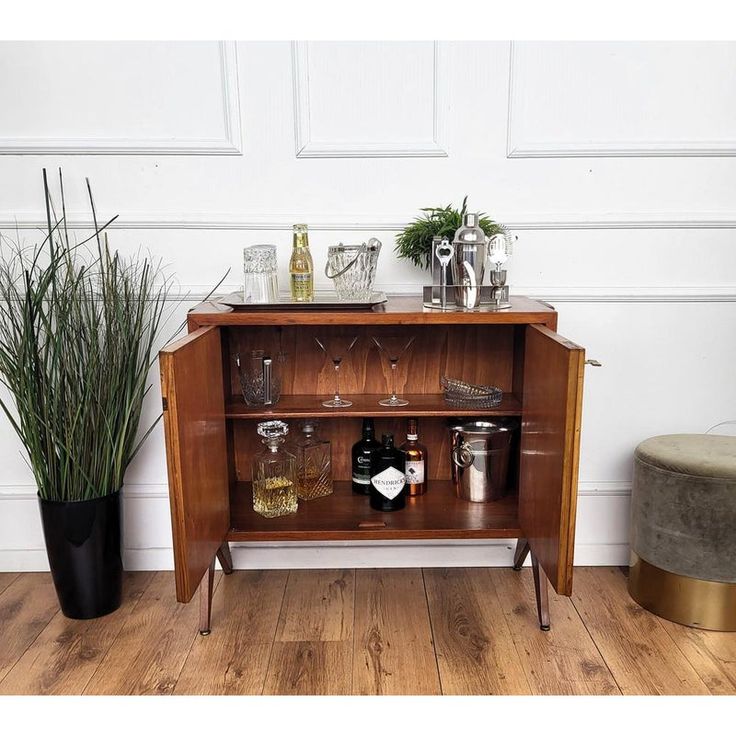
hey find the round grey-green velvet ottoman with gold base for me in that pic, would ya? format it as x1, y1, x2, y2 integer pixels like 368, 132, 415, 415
629, 434, 736, 631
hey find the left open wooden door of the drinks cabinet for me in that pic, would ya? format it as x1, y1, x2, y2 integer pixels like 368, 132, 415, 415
159, 327, 230, 603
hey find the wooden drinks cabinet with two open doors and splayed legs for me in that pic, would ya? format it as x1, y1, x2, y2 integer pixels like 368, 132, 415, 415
160, 296, 585, 634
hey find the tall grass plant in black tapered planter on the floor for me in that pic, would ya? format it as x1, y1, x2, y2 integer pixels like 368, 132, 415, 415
0, 170, 171, 619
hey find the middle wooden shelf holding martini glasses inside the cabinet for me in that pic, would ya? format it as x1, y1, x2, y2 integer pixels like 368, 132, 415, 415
225, 393, 521, 419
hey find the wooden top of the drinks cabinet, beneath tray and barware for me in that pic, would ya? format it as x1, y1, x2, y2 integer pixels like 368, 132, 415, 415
188, 295, 557, 329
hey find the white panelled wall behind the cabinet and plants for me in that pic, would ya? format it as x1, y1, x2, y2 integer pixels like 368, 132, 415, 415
0, 42, 736, 570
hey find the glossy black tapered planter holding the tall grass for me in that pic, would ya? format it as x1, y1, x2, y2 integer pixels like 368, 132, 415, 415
38, 491, 123, 618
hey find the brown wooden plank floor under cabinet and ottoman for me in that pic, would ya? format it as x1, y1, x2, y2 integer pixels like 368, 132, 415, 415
0, 567, 736, 695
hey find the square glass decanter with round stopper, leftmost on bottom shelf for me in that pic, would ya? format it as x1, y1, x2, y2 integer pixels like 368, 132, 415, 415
252, 421, 298, 518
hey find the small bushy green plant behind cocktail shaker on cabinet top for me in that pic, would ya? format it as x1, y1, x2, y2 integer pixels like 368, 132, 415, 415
394, 196, 506, 276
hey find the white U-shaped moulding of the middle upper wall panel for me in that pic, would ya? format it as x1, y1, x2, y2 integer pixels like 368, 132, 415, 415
291, 41, 449, 158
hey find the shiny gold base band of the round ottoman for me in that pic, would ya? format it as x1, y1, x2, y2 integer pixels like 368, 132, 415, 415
629, 552, 736, 631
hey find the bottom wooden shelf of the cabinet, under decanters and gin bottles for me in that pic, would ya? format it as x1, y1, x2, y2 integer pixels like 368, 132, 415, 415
227, 480, 520, 542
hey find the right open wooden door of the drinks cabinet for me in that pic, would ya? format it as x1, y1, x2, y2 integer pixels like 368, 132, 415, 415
519, 325, 585, 595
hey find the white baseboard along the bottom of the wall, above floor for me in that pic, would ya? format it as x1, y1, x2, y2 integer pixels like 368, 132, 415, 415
0, 481, 629, 572
